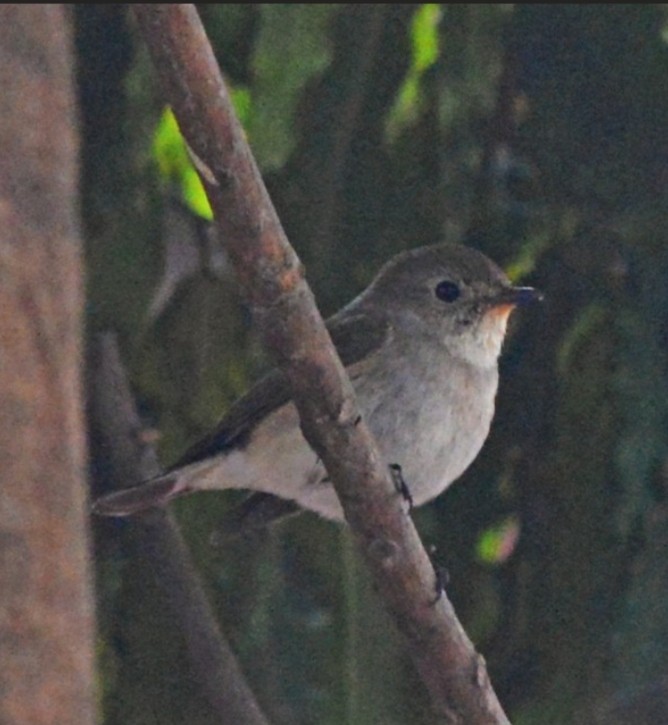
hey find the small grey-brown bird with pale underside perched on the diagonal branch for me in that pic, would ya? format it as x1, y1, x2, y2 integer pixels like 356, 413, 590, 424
93, 243, 542, 522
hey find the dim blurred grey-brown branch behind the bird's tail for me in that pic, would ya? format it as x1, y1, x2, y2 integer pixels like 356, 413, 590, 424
90, 335, 267, 725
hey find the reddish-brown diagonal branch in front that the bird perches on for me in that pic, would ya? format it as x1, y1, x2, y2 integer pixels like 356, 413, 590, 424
133, 4, 508, 725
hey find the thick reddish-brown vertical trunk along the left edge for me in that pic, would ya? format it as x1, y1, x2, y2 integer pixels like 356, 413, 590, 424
0, 5, 95, 725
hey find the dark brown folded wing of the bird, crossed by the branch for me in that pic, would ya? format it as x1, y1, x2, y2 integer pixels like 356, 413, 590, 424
169, 314, 390, 472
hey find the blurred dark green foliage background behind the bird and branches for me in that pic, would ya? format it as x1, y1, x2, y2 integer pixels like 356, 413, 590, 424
76, 4, 668, 725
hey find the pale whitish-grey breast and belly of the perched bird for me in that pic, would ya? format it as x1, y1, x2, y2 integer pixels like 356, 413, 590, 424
177, 320, 498, 520
